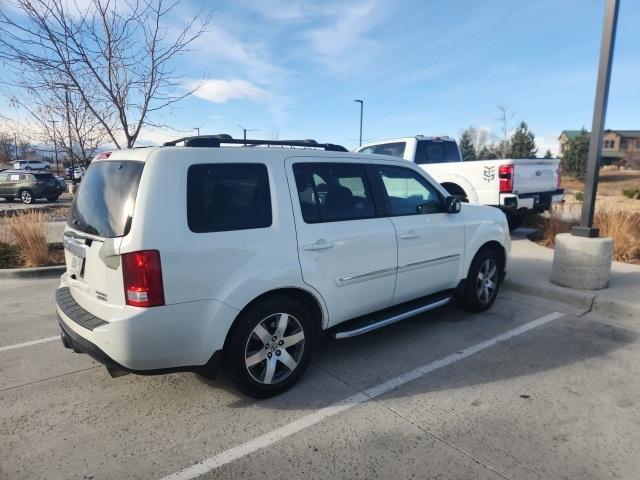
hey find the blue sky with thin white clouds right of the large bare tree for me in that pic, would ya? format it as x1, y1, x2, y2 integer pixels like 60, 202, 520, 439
0, 0, 640, 153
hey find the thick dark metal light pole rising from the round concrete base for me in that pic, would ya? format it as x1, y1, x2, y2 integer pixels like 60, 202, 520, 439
571, 0, 620, 238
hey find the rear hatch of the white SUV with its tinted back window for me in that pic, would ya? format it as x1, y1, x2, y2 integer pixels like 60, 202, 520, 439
64, 160, 144, 318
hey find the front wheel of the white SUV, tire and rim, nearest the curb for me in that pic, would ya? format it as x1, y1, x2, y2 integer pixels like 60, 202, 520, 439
460, 248, 502, 312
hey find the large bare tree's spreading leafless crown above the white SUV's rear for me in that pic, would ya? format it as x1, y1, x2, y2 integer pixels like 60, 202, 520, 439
0, 0, 211, 148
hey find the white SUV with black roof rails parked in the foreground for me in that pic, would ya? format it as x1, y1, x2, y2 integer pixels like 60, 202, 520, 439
56, 136, 510, 397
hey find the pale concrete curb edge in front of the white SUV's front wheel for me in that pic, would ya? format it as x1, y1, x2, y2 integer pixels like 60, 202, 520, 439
502, 279, 640, 320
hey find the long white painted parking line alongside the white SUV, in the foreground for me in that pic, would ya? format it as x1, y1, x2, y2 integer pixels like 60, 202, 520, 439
162, 312, 565, 480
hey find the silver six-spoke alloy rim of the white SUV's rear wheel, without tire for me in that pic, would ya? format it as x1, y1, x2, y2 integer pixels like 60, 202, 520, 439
245, 313, 305, 385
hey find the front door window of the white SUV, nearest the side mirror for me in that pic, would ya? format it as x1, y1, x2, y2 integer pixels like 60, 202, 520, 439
375, 165, 442, 217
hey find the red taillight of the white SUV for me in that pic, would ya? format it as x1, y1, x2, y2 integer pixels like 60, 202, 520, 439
122, 250, 164, 307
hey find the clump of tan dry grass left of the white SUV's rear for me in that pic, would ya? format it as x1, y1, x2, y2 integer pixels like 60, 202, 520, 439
5, 212, 53, 267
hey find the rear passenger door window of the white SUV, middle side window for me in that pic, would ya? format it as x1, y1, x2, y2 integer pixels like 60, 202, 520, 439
293, 163, 376, 223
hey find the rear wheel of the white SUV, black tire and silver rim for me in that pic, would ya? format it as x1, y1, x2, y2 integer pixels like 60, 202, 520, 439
222, 295, 314, 398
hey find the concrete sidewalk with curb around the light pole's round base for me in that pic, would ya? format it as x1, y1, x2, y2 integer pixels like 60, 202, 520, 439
504, 228, 640, 321
